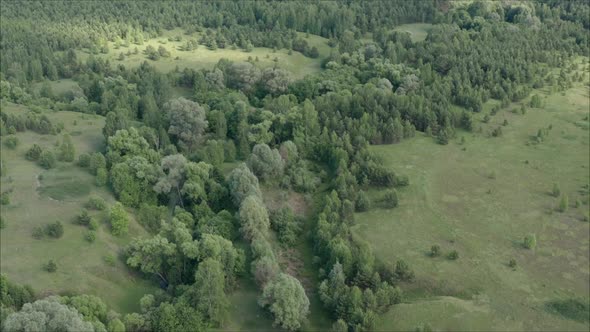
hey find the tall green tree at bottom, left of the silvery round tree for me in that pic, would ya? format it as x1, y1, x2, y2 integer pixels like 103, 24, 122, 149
189, 258, 229, 325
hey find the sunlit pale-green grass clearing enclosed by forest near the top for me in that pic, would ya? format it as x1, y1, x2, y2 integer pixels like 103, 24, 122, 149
78, 29, 330, 78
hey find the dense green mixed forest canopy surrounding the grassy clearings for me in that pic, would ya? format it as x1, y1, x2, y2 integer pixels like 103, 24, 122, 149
0, 0, 590, 331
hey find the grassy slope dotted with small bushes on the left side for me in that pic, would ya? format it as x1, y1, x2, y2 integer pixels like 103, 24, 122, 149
0, 105, 153, 312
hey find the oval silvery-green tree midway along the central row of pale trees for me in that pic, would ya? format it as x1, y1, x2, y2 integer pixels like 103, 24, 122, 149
240, 195, 270, 240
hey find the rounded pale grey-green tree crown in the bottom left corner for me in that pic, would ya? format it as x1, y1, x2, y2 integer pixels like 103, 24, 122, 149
4, 297, 94, 332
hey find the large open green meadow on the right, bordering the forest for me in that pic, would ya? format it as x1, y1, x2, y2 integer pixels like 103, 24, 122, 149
355, 73, 590, 331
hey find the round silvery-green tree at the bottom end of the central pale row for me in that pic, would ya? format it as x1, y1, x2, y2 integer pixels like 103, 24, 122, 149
258, 273, 309, 331
